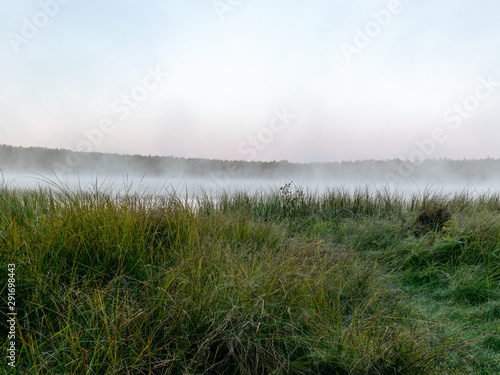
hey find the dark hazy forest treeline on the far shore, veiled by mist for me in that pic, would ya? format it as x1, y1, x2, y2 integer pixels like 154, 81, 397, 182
0, 145, 500, 181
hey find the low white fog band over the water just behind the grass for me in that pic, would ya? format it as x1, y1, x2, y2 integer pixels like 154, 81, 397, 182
1, 171, 500, 198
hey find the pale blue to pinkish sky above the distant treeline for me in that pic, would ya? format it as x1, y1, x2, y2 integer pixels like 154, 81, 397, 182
0, 0, 500, 162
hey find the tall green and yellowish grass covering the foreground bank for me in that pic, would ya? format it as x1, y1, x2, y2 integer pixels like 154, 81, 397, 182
0, 184, 500, 374
